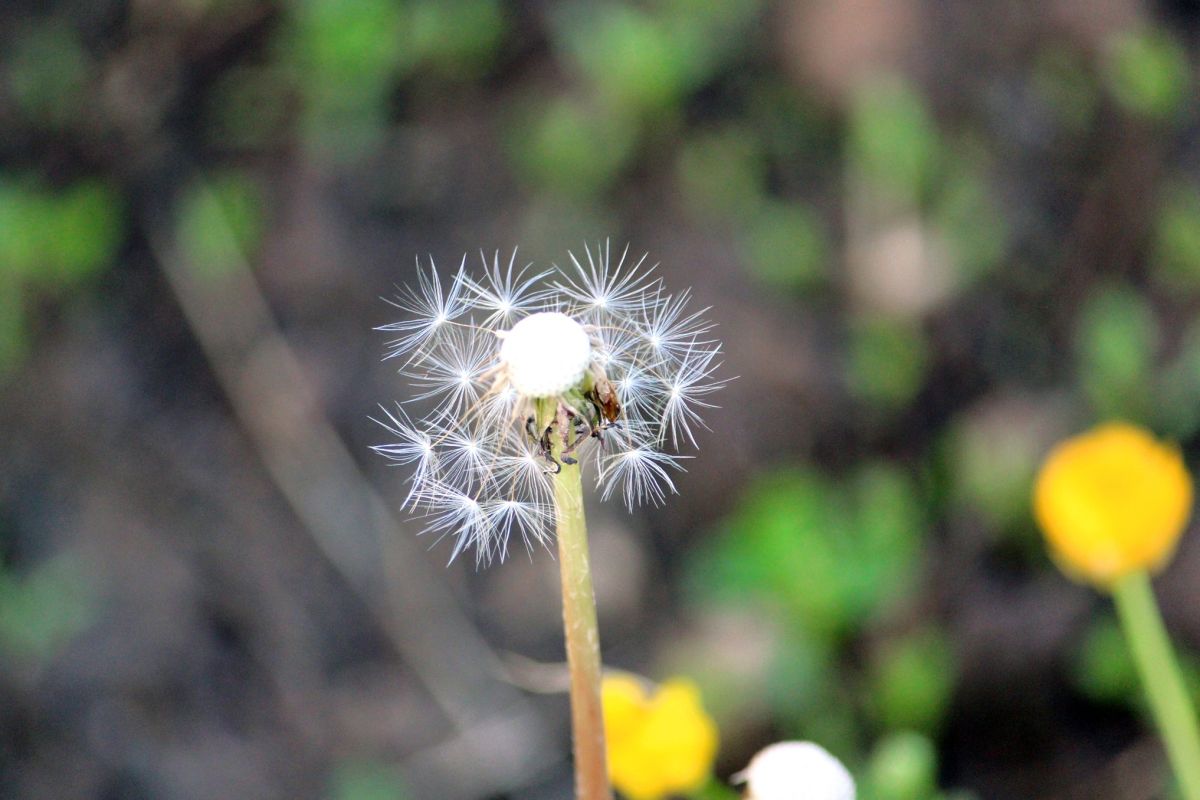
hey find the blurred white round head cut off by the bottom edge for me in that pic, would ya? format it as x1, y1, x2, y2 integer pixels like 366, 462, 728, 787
733, 741, 854, 800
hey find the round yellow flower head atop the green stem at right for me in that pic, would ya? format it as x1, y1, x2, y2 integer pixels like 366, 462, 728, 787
1033, 422, 1192, 587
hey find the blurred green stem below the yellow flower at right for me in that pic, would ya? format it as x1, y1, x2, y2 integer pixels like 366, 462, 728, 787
1112, 572, 1200, 800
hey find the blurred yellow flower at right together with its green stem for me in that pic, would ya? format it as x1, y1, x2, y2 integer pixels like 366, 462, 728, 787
1033, 423, 1200, 800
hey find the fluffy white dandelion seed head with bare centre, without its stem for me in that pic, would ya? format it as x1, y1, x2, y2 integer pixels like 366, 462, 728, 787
374, 242, 726, 563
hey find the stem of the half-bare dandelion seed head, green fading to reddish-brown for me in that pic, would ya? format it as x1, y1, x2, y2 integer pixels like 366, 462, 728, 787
549, 402, 612, 800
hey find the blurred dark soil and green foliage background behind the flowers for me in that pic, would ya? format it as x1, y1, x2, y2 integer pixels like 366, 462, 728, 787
7, 0, 1200, 800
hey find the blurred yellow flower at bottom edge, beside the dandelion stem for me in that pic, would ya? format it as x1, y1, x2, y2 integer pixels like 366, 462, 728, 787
602, 674, 716, 800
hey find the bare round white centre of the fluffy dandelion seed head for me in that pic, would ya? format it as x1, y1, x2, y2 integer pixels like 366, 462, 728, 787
500, 311, 592, 397
